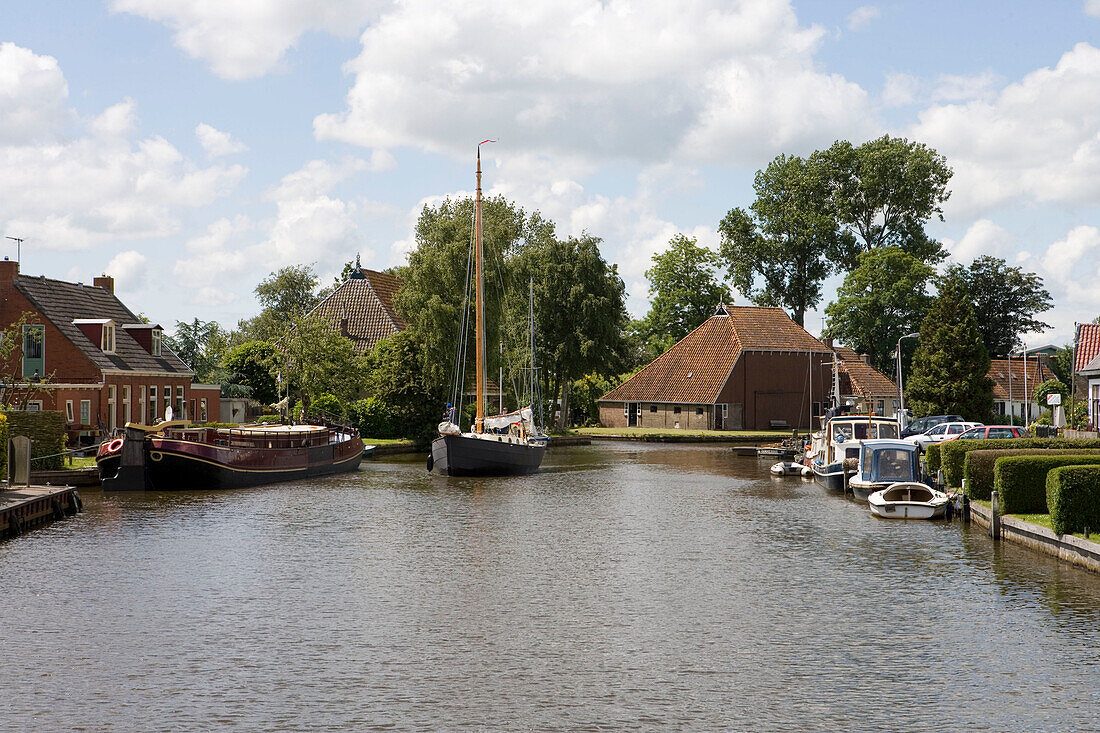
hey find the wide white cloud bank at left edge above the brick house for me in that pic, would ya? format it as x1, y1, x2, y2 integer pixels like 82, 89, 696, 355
0, 44, 246, 251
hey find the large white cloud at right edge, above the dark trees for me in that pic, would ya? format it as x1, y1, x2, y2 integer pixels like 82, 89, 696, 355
909, 43, 1100, 216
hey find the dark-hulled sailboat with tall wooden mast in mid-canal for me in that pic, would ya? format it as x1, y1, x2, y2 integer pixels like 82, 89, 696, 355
428, 140, 548, 475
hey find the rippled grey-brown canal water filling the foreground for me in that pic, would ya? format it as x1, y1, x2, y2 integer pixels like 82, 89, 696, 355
0, 435, 1100, 731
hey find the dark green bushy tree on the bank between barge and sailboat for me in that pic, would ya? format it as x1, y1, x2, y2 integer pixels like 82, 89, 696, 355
366, 331, 446, 442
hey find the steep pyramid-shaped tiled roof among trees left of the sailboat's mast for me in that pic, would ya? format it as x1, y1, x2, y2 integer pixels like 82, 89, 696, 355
312, 270, 405, 353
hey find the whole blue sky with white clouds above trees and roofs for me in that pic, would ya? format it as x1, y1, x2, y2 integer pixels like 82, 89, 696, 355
0, 0, 1100, 346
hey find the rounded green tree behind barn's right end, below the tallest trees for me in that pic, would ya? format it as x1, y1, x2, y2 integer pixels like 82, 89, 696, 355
825, 247, 935, 374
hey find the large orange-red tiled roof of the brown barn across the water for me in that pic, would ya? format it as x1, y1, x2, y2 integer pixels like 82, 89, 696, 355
601, 306, 828, 404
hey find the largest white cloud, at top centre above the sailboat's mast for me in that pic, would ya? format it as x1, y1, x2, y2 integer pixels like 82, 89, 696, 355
314, 0, 873, 165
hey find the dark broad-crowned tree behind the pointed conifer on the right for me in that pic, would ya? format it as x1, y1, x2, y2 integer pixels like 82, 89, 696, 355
945, 255, 1053, 357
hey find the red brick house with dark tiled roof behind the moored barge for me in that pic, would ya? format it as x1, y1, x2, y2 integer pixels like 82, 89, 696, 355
0, 258, 219, 444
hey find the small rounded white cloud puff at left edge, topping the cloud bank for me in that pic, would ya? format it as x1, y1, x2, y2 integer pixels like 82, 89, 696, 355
0, 42, 68, 145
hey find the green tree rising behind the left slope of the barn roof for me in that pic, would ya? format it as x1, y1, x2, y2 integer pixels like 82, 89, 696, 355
639, 234, 732, 343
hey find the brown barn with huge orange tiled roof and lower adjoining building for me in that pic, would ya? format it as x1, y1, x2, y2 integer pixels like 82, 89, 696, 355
600, 306, 894, 430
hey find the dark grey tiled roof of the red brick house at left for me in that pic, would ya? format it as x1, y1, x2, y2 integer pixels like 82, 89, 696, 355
14, 276, 193, 374
